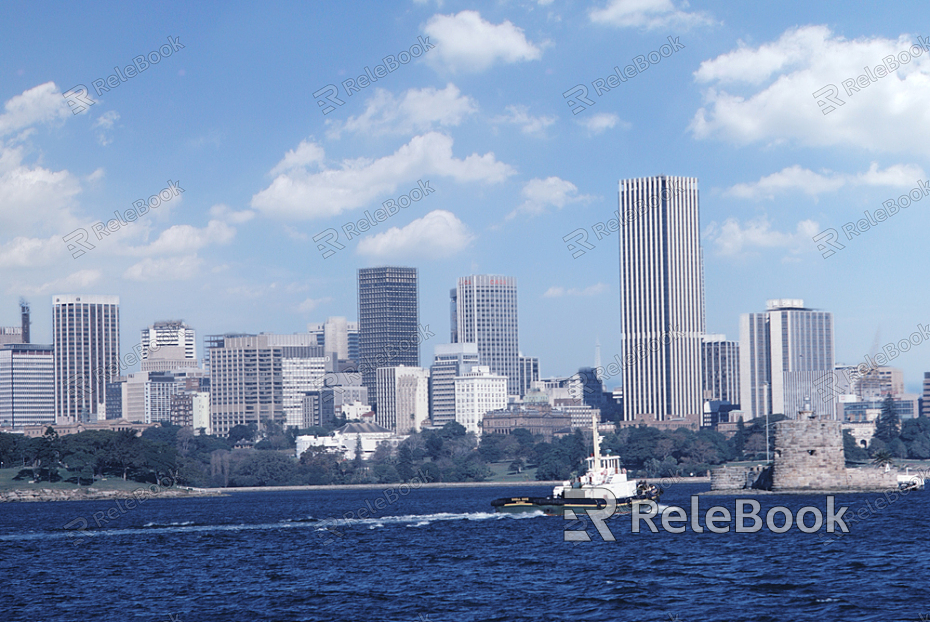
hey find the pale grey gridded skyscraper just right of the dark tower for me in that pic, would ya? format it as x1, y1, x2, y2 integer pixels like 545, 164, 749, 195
450, 274, 520, 395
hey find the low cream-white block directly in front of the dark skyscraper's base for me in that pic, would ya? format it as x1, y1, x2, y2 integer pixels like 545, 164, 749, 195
375, 365, 429, 436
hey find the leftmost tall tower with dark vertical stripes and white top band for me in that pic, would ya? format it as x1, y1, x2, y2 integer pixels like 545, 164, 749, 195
52, 295, 120, 423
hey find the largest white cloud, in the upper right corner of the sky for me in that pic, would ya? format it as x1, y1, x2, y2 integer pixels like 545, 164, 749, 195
690, 26, 930, 154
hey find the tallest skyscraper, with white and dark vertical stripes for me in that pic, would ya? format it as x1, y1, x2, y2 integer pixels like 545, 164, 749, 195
618, 175, 704, 420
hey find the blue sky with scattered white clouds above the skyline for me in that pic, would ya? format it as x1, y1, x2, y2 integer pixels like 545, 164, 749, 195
0, 0, 930, 391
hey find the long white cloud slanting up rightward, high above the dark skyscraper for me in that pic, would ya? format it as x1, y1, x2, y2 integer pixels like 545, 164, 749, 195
252, 132, 514, 220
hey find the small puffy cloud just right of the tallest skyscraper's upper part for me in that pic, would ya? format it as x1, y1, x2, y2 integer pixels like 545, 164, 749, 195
704, 217, 820, 258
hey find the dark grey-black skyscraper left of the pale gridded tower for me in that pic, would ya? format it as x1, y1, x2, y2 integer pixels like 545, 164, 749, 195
358, 266, 420, 406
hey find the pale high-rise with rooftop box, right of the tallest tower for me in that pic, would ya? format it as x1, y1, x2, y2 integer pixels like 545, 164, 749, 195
739, 298, 836, 419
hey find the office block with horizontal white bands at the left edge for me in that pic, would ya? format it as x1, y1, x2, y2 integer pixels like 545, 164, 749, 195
0, 343, 55, 428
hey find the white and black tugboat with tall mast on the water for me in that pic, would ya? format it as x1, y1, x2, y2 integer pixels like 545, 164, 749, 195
491, 414, 662, 516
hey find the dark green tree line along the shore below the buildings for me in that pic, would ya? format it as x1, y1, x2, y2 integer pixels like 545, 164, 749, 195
0, 408, 930, 488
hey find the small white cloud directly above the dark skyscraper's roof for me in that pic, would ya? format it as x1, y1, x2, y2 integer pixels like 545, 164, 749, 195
356, 210, 475, 259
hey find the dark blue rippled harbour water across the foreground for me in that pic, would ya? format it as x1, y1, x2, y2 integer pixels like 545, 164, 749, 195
0, 484, 930, 622
